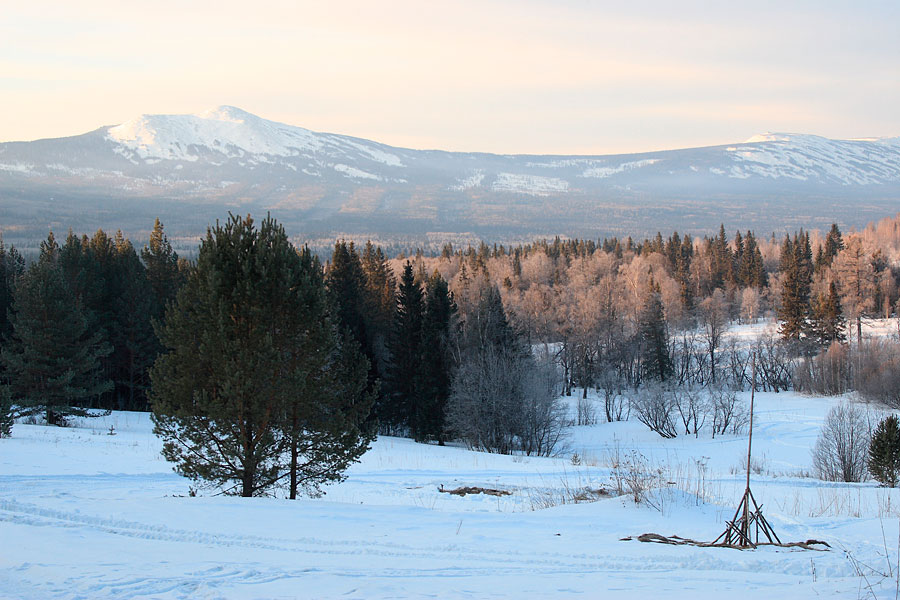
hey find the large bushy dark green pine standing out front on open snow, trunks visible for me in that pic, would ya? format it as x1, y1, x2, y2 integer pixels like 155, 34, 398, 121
151, 216, 368, 497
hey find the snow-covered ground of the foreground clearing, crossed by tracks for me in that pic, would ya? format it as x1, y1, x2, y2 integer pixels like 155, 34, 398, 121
0, 393, 900, 600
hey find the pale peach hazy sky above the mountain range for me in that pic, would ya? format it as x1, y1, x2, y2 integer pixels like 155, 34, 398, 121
0, 0, 900, 154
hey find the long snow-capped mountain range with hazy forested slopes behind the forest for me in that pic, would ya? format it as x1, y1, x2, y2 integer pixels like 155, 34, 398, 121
0, 106, 900, 247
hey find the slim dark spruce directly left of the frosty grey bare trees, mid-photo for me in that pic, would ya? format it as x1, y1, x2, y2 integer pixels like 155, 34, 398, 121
414, 271, 456, 445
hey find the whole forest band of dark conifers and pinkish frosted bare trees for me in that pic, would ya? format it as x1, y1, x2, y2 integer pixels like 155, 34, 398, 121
0, 211, 900, 497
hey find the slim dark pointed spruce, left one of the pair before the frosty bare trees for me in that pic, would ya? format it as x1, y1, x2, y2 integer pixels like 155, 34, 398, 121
385, 261, 424, 440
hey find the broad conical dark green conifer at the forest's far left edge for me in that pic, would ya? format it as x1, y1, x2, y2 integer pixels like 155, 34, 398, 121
0, 253, 112, 425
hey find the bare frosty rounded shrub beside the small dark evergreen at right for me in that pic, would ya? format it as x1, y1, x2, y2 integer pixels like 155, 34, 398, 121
813, 403, 871, 482
